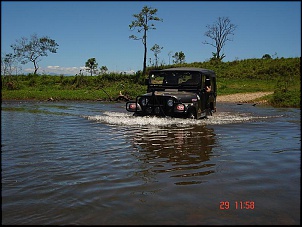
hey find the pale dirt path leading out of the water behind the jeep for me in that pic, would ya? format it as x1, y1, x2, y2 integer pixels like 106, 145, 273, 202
216, 92, 273, 103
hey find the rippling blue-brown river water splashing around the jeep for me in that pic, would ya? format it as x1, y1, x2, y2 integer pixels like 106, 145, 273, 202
1, 101, 301, 225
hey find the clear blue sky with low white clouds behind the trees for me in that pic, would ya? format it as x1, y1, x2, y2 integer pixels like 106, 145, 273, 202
1, 1, 301, 75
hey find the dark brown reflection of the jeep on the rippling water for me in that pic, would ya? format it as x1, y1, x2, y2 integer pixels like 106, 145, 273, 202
133, 125, 215, 185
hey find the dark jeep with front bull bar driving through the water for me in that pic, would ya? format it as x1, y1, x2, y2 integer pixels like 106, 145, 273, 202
126, 67, 217, 119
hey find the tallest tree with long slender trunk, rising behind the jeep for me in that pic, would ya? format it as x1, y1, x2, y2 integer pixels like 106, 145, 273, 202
129, 6, 163, 76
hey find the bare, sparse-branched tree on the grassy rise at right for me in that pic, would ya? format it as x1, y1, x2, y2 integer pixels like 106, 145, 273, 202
203, 17, 237, 60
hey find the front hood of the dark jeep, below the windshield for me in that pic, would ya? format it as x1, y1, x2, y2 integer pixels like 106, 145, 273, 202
144, 89, 199, 103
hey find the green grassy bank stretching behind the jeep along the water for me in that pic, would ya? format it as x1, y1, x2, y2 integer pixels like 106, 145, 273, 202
1, 58, 301, 108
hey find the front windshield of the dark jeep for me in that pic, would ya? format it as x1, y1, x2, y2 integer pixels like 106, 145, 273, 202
150, 71, 201, 86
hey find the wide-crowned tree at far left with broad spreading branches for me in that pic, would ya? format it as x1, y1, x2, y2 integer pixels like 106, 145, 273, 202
11, 34, 59, 74
